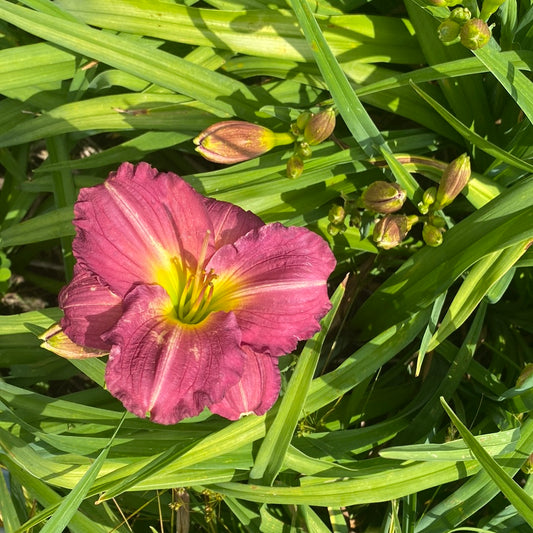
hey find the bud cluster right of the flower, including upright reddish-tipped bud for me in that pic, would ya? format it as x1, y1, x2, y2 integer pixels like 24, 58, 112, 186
328, 154, 470, 250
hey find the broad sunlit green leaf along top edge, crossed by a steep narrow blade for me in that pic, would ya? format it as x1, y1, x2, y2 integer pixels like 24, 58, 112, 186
55, 0, 422, 64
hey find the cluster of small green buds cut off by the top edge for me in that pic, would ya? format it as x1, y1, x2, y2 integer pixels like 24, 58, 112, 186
428, 0, 490, 50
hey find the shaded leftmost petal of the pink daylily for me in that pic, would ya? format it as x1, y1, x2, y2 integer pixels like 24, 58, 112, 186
59, 265, 122, 355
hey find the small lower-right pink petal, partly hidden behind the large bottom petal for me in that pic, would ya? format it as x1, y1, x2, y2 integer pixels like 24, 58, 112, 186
209, 345, 281, 420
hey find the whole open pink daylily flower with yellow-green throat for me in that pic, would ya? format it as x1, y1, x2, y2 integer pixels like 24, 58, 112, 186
52, 163, 335, 424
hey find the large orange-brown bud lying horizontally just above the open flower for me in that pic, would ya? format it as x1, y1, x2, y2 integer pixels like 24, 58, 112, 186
193, 120, 294, 165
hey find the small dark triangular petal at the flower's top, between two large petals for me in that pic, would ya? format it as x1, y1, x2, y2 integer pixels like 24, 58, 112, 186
204, 198, 265, 249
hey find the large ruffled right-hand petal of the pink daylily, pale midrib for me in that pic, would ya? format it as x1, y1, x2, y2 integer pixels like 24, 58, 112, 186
206, 224, 335, 356
